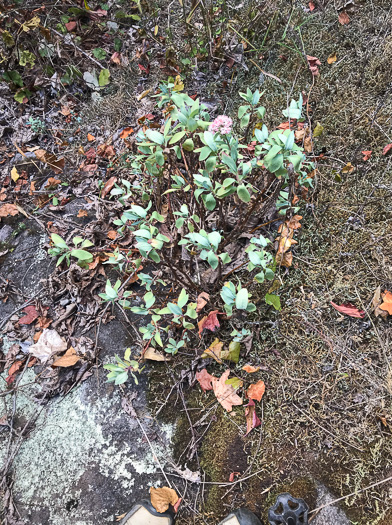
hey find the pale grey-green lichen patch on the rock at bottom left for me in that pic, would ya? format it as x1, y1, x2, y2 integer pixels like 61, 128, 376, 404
3, 369, 173, 525
